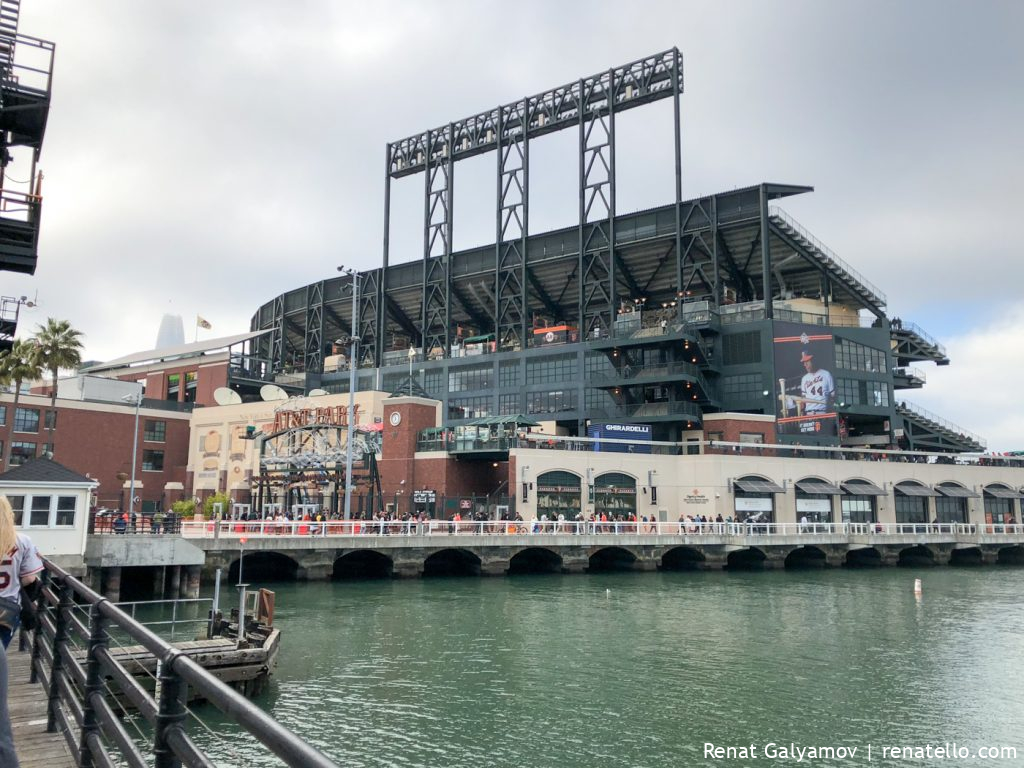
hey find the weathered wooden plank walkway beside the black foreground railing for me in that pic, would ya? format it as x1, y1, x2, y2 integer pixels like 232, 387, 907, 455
6, 642, 75, 768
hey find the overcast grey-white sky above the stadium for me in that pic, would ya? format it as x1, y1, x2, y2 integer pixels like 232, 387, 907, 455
8, 0, 1024, 451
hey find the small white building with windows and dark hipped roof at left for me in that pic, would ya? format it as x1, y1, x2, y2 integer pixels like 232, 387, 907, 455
0, 459, 98, 572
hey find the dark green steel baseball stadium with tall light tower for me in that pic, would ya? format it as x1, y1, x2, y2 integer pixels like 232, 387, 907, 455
239, 49, 984, 452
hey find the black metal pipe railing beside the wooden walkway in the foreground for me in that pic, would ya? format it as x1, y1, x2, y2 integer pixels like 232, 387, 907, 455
32, 560, 338, 768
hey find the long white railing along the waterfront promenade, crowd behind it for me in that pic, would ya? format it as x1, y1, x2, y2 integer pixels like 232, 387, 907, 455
181, 520, 1024, 542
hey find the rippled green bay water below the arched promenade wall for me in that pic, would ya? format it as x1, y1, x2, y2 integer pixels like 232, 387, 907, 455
189, 567, 1024, 768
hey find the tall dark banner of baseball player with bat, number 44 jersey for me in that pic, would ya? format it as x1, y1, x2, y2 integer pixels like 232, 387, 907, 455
772, 322, 839, 437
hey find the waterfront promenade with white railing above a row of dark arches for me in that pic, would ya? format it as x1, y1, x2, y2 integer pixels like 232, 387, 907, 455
169, 520, 1024, 580
